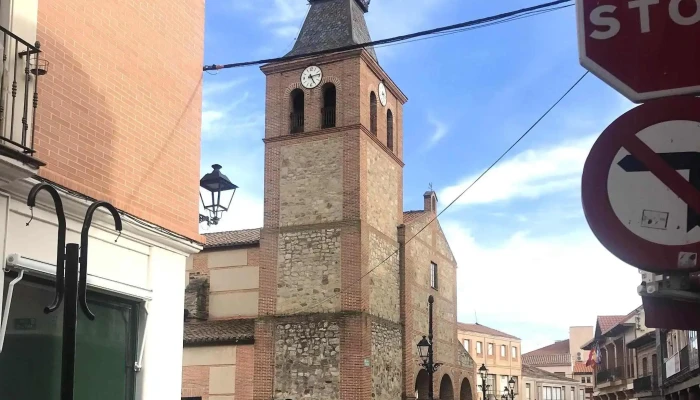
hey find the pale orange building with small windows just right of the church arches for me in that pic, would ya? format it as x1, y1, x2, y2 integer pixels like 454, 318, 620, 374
457, 323, 523, 398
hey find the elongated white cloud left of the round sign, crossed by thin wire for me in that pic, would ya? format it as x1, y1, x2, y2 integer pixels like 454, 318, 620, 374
440, 136, 595, 205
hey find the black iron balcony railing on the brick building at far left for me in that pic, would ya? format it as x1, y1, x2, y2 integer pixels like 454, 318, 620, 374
0, 26, 43, 161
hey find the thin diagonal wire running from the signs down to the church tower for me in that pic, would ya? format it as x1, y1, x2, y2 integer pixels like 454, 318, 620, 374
292, 71, 588, 314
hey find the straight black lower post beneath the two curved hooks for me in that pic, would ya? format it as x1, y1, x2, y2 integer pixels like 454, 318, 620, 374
61, 243, 79, 400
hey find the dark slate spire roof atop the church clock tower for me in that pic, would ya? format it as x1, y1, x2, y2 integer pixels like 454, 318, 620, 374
287, 0, 377, 60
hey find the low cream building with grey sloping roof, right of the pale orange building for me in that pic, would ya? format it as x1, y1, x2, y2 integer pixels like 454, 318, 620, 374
518, 364, 586, 400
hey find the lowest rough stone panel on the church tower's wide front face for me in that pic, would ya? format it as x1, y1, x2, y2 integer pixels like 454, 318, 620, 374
274, 321, 340, 400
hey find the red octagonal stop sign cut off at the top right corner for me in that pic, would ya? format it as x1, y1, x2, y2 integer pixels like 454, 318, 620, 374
576, 0, 700, 103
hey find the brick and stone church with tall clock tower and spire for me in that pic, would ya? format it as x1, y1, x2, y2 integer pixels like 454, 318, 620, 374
182, 0, 475, 400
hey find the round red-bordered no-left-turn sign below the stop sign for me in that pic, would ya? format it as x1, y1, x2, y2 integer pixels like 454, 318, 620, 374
581, 96, 700, 274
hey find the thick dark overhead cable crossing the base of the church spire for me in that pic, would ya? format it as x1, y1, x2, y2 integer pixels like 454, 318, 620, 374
203, 0, 573, 71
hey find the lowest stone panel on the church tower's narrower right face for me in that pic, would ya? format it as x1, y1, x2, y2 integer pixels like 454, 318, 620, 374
371, 321, 402, 400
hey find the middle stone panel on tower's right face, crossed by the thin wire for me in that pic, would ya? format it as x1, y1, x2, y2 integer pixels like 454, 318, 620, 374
369, 232, 401, 322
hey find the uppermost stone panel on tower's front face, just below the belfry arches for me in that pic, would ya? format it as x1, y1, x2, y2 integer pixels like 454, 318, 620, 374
279, 138, 343, 227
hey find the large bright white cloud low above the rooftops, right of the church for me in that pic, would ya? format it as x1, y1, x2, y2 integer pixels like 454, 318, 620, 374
442, 221, 641, 349
